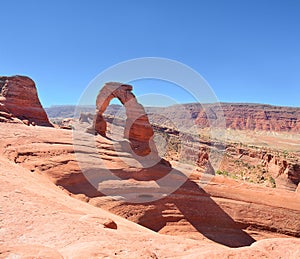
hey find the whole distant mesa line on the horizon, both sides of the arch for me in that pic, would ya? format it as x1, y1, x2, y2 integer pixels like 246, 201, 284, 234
46, 103, 300, 133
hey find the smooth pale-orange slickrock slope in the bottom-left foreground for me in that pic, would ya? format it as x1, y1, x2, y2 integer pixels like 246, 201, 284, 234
0, 157, 213, 258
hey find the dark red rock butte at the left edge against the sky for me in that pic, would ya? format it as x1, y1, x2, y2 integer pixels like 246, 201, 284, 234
0, 76, 52, 127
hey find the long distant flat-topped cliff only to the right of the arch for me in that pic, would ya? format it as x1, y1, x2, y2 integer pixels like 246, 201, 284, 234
148, 103, 300, 133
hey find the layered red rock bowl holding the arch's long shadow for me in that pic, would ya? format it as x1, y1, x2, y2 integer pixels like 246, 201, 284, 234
0, 123, 300, 246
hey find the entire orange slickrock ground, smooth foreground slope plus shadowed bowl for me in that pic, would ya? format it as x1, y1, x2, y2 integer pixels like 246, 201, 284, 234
0, 123, 300, 258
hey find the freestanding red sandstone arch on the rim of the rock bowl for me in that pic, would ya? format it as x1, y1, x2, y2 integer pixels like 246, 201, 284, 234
90, 82, 154, 156
